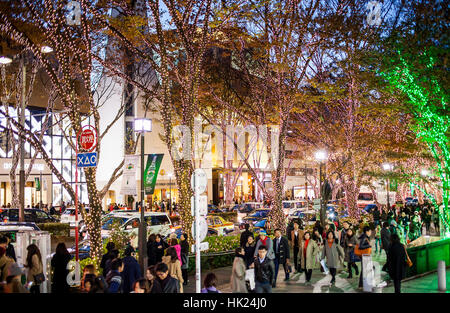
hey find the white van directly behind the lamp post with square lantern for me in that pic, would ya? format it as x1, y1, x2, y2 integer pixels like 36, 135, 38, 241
102, 211, 174, 247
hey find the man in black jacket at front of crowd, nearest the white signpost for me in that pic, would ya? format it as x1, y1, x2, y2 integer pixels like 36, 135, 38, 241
254, 245, 275, 293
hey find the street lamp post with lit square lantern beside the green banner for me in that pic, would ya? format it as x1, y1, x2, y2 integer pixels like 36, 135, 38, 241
134, 118, 152, 273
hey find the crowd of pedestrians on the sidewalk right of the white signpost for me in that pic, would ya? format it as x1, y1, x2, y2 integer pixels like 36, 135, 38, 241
231, 197, 432, 293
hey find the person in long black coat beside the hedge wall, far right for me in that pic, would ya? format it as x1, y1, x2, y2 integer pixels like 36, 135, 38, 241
387, 234, 406, 293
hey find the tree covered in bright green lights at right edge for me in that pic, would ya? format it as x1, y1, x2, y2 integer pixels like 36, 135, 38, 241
380, 51, 450, 236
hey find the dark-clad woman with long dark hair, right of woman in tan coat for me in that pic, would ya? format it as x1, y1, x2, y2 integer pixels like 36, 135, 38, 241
51, 242, 72, 293
